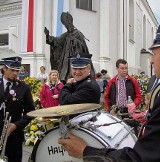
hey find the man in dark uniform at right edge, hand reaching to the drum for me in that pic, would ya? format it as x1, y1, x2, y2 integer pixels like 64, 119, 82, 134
59, 26, 160, 162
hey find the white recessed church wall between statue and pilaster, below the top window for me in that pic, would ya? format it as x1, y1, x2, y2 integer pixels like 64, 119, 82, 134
69, 0, 100, 72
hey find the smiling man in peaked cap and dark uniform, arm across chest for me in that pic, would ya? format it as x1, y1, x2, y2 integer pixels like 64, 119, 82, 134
59, 53, 100, 105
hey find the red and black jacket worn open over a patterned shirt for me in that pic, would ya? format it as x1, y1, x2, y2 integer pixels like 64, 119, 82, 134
105, 75, 142, 111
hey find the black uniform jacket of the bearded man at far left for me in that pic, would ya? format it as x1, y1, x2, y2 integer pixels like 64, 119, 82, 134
0, 78, 35, 140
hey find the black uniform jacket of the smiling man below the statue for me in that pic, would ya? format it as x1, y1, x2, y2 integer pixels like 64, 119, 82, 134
59, 75, 100, 105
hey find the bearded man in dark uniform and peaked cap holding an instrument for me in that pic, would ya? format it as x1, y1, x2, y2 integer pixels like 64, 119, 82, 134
0, 57, 34, 162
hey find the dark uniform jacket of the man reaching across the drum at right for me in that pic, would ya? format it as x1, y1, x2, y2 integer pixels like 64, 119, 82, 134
83, 84, 160, 162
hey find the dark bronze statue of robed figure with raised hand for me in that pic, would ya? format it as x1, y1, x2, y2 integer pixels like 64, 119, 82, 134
44, 12, 89, 80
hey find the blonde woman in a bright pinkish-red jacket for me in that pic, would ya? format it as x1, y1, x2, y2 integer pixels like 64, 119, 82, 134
40, 70, 63, 108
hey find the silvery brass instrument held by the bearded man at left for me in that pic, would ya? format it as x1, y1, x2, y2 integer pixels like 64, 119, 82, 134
0, 112, 11, 162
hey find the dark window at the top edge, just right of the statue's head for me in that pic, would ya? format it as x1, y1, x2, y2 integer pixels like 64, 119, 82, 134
76, 0, 92, 11
